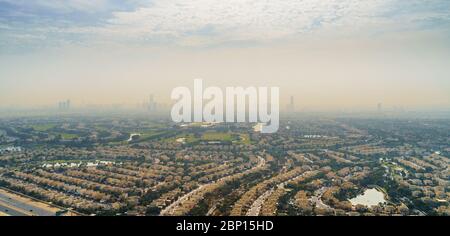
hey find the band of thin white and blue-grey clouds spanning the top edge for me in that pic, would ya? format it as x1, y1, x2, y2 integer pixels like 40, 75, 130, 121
0, 0, 450, 50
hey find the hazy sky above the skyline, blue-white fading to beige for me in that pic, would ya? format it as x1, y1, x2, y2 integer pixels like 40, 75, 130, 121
0, 0, 450, 110
